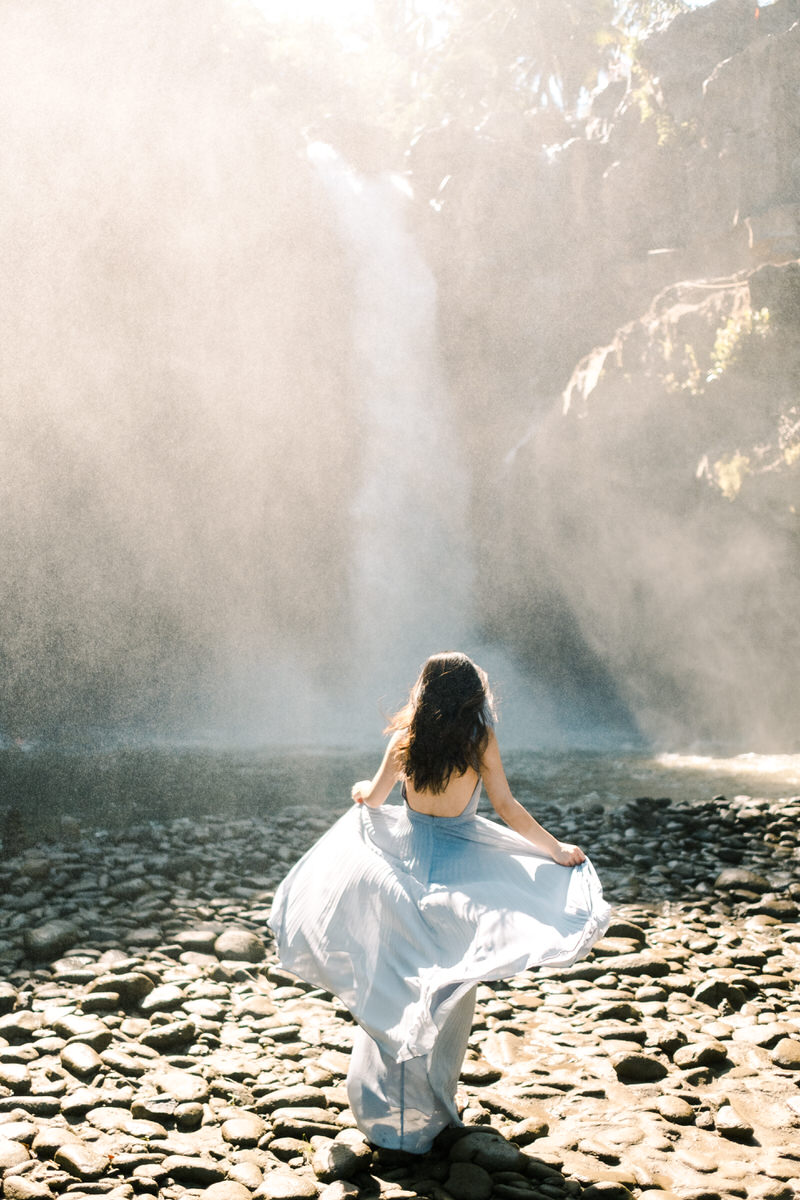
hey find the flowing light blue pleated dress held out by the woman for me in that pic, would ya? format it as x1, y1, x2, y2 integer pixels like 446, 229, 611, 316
270, 780, 610, 1153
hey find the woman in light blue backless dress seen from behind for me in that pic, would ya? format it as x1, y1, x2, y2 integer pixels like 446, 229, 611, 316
270, 653, 610, 1153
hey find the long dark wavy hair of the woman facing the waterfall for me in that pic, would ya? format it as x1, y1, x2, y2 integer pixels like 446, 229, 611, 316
386, 653, 494, 794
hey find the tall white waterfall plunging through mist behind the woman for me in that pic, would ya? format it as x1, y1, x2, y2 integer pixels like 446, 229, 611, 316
308, 143, 563, 746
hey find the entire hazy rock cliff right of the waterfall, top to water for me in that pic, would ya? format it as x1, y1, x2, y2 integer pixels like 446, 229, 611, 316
444, 0, 800, 749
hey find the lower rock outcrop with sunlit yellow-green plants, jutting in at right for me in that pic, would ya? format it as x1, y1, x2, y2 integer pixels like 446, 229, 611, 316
494, 263, 800, 749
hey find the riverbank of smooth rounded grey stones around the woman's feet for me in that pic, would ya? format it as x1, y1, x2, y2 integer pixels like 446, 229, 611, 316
0, 797, 800, 1200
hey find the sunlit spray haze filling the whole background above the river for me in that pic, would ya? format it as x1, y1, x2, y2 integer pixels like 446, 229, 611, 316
0, 0, 800, 750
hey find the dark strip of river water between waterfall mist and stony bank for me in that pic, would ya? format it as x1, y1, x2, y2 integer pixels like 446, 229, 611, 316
0, 745, 800, 840
